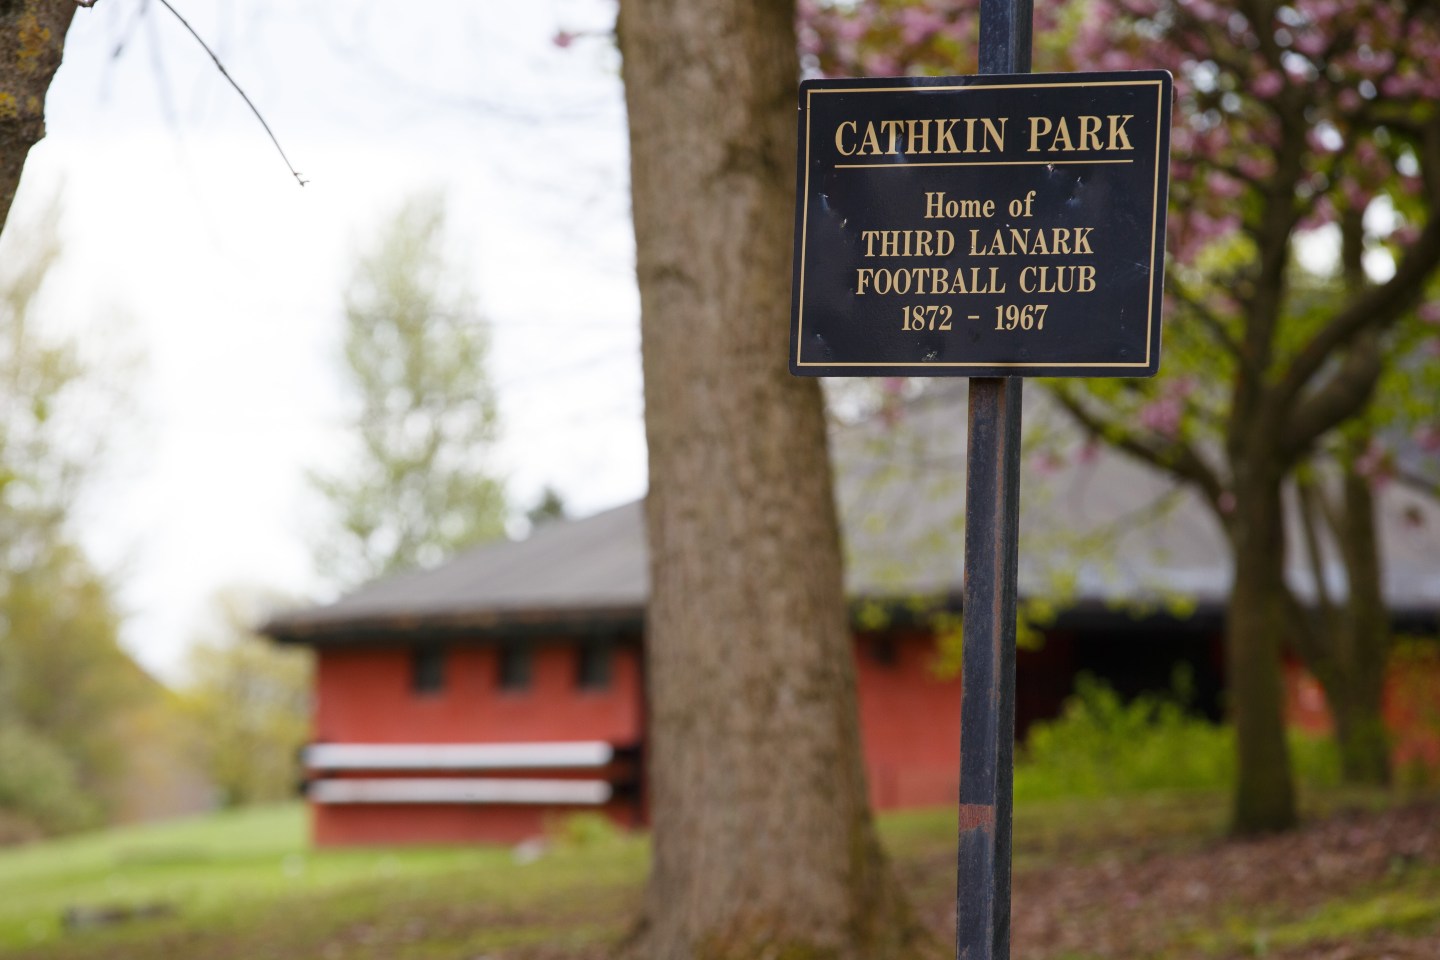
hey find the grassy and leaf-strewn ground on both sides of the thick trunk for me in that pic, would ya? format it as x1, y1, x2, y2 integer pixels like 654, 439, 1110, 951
0, 792, 1440, 960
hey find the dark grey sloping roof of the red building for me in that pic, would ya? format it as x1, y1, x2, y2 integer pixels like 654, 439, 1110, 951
264, 381, 1440, 643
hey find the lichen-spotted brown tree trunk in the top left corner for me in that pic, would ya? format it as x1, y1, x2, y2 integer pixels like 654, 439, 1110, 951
0, 0, 75, 229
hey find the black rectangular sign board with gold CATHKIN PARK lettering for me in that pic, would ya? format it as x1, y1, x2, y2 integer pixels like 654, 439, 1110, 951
791, 71, 1171, 377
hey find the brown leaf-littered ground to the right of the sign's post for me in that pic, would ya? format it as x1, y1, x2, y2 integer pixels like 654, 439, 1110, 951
926, 802, 1440, 960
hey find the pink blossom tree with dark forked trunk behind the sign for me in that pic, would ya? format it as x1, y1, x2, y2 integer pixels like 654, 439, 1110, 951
801, 0, 1440, 832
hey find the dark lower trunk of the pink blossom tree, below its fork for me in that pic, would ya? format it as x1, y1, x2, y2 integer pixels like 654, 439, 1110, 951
1225, 459, 1296, 833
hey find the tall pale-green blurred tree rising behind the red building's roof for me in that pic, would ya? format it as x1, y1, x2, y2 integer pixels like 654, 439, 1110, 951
314, 196, 505, 586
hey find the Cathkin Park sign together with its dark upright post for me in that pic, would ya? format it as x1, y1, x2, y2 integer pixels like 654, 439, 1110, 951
789, 11, 1171, 960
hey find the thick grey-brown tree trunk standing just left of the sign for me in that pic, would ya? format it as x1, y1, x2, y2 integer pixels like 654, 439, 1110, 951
619, 0, 916, 960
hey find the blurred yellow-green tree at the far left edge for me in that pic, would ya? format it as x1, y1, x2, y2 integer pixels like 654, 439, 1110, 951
0, 201, 156, 820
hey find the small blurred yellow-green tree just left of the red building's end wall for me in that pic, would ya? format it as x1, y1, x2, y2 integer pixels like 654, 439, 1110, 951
181, 587, 312, 806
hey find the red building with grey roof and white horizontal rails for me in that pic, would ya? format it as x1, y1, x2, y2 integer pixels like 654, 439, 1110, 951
265, 391, 1440, 845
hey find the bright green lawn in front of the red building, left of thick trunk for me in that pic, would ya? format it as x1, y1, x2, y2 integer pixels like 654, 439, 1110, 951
0, 805, 644, 956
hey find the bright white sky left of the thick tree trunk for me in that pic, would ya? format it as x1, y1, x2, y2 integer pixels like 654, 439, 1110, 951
7, 0, 645, 678
